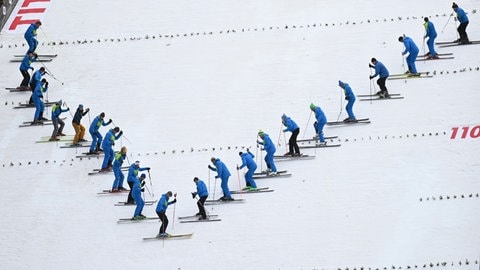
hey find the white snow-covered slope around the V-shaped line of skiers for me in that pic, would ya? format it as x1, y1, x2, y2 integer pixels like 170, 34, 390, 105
0, 0, 480, 270
